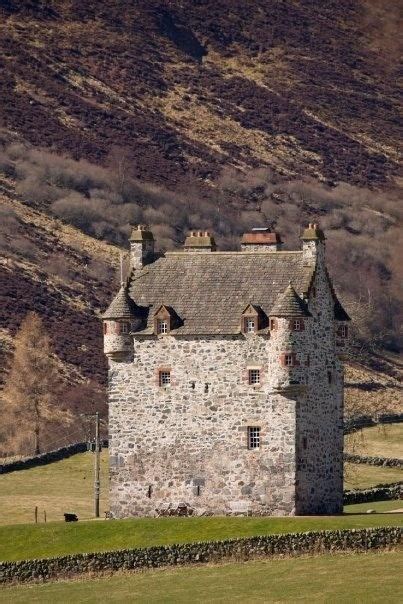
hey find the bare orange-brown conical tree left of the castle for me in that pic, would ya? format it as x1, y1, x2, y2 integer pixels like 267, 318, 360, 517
3, 312, 66, 454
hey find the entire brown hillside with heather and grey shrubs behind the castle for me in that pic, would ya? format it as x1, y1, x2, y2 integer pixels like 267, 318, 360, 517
0, 0, 403, 452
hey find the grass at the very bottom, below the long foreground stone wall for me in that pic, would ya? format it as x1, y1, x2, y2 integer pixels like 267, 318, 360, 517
2, 551, 403, 604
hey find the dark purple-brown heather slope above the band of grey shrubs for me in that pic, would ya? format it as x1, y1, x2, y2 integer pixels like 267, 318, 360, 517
0, 0, 401, 189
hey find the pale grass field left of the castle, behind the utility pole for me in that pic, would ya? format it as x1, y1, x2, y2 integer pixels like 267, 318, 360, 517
0, 450, 109, 524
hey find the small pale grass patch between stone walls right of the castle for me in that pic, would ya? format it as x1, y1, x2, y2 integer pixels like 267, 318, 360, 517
345, 423, 403, 459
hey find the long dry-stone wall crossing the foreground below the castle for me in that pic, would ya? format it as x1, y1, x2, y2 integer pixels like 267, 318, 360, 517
0, 527, 402, 583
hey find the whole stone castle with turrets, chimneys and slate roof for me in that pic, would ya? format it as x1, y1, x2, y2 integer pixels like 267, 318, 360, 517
103, 224, 349, 518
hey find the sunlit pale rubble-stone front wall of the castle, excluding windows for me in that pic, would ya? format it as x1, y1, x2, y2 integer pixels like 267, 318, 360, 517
109, 335, 295, 517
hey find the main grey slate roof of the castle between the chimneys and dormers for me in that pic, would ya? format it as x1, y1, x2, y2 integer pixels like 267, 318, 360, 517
128, 251, 314, 335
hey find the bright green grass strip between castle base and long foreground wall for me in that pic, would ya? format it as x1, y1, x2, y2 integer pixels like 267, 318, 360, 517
0, 514, 403, 560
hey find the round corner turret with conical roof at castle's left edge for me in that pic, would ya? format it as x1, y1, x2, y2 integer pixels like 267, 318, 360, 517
102, 283, 142, 361
